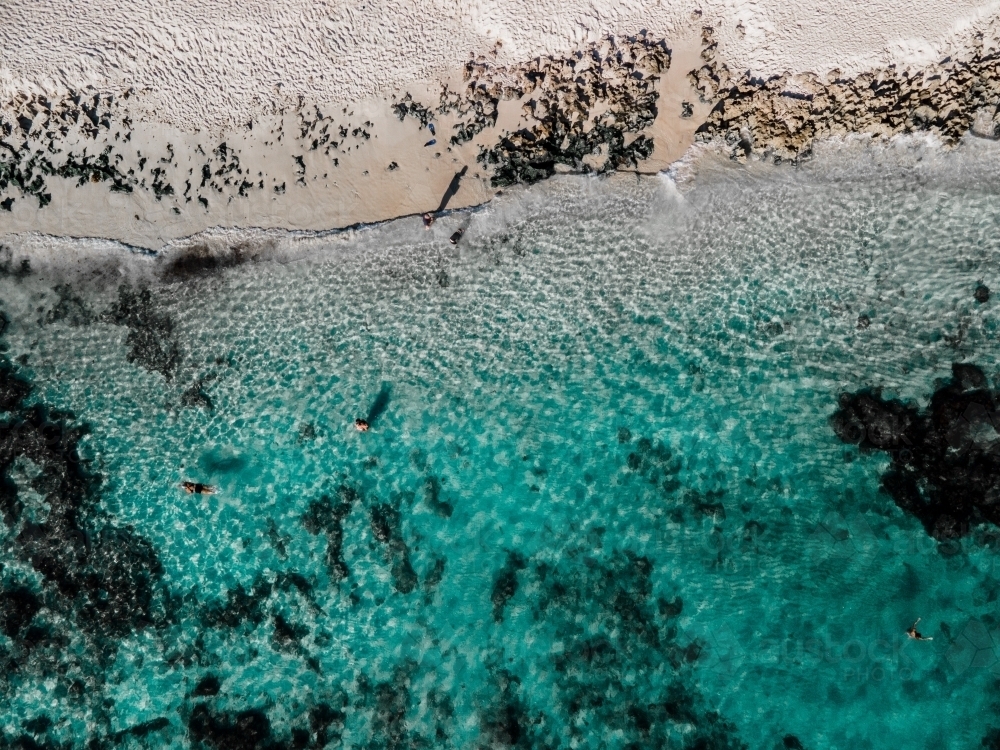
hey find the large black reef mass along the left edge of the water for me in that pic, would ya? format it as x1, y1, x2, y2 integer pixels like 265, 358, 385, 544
0, 318, 171, 688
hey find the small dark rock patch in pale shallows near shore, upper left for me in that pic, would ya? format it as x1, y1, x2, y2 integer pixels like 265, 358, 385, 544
101, 284, 181, 380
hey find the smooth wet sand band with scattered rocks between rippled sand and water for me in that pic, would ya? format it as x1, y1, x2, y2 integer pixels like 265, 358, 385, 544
0, 9, 1000, 253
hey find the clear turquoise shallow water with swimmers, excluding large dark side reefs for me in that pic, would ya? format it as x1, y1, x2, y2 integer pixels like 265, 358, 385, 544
0, 138, 1000, 750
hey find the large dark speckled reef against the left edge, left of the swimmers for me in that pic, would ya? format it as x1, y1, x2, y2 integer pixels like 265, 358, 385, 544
0, 319, 172, 747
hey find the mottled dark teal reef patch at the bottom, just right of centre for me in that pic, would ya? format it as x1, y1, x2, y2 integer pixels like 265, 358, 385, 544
480, 550, 746, 750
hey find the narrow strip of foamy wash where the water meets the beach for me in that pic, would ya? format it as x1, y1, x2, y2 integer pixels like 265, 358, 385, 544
7, 133, 1000, 283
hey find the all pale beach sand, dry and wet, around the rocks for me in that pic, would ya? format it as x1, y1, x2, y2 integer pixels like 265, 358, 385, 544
0, 0, 1000, 249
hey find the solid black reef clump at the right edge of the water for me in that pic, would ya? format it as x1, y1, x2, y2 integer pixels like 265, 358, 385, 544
831, 364, 1000, 541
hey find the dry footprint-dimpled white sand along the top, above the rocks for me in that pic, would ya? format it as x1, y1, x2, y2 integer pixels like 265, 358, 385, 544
0, 0, 998, 130
